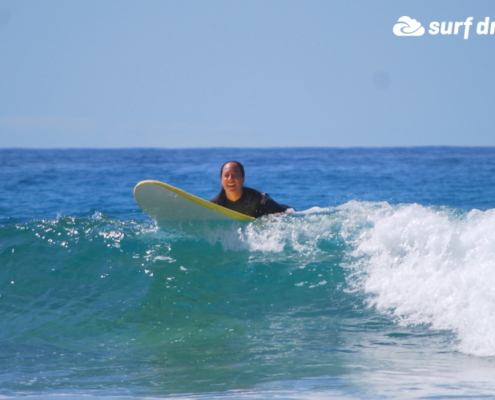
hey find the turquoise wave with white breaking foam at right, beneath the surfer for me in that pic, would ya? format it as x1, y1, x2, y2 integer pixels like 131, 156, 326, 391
0, 201, 495, 364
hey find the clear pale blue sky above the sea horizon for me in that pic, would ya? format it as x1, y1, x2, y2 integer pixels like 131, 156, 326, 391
0, 0, 495, 148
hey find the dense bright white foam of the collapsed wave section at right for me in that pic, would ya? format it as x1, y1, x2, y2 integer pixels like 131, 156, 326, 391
341, 202, 495, 356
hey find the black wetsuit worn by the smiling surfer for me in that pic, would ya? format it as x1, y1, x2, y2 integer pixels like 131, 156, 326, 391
210, 187, 291, 218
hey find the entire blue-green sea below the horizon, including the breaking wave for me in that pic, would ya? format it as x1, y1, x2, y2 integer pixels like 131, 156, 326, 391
0, 147, 495, 399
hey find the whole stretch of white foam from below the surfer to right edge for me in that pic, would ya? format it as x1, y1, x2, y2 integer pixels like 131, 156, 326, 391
204, 201, 495, 356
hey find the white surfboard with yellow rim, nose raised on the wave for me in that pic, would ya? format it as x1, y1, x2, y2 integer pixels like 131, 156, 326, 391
134, 180, 254, 222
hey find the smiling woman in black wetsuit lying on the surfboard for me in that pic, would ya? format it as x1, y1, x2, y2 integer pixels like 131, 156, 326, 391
210, 161, 291, 218
